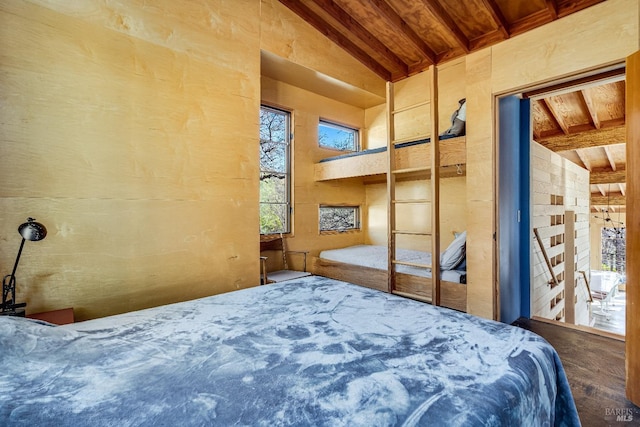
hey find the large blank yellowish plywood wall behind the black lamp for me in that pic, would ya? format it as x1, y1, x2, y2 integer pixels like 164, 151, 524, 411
0, 0, 260, 320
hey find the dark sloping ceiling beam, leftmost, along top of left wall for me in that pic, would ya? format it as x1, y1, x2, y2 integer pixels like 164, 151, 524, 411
280, 0, 391, 80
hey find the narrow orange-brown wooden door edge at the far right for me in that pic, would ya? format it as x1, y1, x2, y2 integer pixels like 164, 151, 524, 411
625, 52, 640, 406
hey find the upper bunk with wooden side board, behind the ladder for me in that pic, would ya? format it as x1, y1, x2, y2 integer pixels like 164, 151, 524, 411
314, 136, 467, 181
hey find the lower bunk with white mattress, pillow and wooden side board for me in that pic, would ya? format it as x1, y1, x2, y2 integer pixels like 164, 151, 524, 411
312, 232, 467, 311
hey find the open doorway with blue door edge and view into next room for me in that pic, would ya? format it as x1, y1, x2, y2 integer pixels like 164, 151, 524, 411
498, 66, 626, 335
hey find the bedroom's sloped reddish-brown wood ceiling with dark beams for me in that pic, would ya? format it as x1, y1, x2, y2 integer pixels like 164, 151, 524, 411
280, 0, 604, 81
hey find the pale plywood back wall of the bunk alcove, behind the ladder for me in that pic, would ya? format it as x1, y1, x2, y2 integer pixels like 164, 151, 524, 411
365, 59, 467, 252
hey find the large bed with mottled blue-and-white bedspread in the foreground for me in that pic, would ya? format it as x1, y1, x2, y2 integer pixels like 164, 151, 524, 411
0, 276, 579, 426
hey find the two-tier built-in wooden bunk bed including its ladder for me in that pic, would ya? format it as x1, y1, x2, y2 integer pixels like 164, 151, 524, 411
312, 72, 467, 311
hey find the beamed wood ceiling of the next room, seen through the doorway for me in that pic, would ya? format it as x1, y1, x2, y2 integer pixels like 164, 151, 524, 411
525, 68, 627, 214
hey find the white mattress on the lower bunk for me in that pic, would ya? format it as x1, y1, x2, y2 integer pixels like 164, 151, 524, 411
320, 245, 467, 283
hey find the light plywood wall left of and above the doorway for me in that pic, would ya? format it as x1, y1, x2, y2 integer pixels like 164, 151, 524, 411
466, 0, 640, 317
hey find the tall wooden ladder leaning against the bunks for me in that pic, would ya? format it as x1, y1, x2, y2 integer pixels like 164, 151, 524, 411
387, 66, 440, 305
